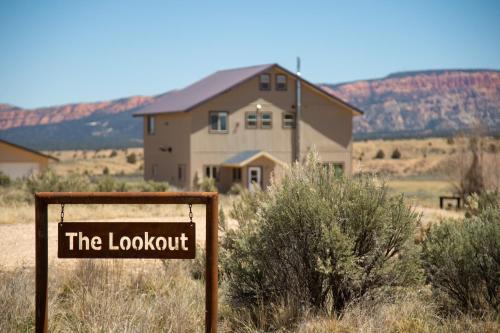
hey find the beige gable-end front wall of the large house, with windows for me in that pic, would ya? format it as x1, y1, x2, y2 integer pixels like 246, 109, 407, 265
191, 66, 352, 188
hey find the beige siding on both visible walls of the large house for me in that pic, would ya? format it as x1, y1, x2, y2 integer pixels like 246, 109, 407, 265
144, 67, 360, 191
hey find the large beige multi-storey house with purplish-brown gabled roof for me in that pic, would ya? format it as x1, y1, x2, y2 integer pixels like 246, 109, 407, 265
134, 64, 362, 191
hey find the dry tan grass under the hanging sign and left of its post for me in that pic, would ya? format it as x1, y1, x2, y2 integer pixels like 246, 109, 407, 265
0, 261, 204, 332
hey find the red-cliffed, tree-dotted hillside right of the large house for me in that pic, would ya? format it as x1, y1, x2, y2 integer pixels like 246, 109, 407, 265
322, 70, 500, 138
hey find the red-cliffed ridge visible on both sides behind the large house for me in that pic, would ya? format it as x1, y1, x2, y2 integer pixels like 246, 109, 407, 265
0, 70, 500, 149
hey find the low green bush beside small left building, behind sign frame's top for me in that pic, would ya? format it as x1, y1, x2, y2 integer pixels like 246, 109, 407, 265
25, 169, 91, 198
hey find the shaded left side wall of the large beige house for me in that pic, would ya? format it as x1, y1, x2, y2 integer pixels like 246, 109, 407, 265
144, 113, 191, 188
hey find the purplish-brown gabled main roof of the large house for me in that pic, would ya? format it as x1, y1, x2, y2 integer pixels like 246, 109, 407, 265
134, 64, 363, 117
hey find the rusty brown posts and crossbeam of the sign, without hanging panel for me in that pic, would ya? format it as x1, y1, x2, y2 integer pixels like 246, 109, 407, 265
35, 192, 218, 333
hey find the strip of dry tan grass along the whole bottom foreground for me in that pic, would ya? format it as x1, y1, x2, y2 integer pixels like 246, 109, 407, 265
0, 260, 500, 333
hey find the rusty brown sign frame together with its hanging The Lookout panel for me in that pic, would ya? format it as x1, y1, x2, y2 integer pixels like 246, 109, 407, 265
35, 192, 218, 333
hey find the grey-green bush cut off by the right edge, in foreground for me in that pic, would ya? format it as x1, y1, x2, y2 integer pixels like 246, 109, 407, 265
422, 198, 500, 316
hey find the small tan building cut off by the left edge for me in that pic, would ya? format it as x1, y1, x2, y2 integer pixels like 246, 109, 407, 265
0, 140, 59, 178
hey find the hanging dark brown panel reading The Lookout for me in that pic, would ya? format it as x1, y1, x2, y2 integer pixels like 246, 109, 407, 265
57, 222, 196, 259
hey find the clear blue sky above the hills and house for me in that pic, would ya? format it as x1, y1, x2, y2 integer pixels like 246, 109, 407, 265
0, 0, 500, 108
